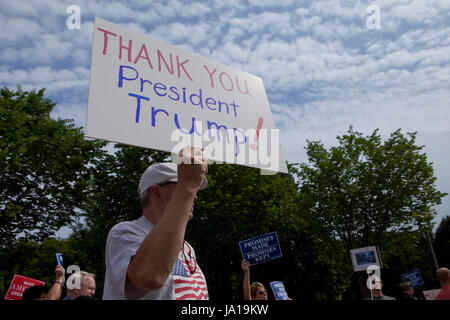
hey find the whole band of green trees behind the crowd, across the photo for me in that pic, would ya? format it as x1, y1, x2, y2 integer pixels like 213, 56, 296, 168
0, 88, 449, 300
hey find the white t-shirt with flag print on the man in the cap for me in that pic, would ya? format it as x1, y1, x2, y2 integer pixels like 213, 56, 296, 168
103, 216, 209, 300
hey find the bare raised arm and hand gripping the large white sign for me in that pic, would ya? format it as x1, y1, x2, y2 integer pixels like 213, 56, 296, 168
127, 147, 208, 291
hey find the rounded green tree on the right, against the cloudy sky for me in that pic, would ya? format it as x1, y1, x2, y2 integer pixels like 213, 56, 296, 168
297, 127, 446, 298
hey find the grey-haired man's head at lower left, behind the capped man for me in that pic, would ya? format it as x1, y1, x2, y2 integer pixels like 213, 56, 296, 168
64, 271, 96, 300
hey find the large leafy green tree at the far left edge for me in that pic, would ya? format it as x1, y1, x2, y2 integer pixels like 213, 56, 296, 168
0, 87, 104, 248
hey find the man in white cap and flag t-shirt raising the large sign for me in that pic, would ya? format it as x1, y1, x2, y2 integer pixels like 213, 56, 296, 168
103, 147, 208, 300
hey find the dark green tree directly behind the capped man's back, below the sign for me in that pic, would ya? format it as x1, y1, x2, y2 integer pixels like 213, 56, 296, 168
76, 144, 169, 285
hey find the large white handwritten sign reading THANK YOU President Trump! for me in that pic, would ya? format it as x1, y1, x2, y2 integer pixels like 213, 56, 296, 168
86, 18, 288, 173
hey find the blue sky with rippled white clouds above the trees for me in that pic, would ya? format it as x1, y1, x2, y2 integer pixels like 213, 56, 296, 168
0, 0, 450, 230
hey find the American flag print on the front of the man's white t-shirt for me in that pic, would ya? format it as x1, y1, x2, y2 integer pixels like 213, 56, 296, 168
172, 241, 209, 300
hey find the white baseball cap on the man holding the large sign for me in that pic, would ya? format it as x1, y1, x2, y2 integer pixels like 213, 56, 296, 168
138, 162, 208, 198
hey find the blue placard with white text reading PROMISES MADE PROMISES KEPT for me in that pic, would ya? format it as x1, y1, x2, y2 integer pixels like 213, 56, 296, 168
239, 232, 281, 266
